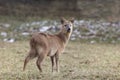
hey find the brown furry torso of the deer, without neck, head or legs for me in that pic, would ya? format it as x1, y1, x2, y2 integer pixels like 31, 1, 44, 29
30, 33, 64, 56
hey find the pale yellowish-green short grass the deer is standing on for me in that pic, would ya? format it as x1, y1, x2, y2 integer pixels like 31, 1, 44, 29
0, 41, 120, 80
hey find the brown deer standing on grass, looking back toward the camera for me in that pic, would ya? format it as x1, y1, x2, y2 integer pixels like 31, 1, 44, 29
23, 18, 74, 72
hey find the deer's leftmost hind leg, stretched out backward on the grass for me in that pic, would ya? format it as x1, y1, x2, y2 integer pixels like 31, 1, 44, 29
23, 49, 37, 71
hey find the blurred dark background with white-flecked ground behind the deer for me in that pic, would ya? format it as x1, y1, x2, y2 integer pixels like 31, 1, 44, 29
0, 0, 120, 43
